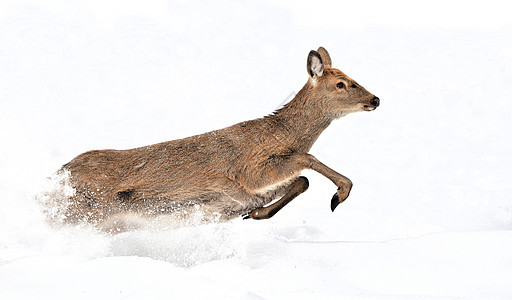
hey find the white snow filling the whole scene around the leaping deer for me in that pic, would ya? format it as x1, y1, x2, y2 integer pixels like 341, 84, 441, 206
0, 1, 512, 299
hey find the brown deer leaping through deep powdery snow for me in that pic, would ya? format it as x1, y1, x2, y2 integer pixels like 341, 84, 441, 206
48, 47, 379, 227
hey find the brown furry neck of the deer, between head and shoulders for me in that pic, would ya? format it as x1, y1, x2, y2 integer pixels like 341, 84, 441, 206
274, 83, 334, 152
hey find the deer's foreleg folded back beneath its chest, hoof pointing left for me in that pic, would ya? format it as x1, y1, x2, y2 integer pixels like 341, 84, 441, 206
243, 176, 309, 220
